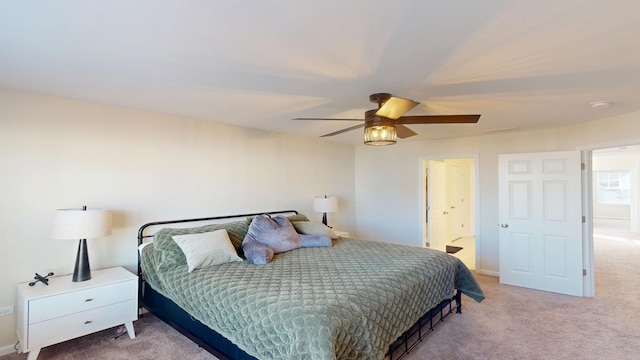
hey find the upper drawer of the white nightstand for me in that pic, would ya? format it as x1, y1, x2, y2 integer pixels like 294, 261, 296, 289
29, 281, 138, 324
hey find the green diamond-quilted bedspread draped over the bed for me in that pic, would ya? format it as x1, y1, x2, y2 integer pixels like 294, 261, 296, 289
142, 239, 484, 360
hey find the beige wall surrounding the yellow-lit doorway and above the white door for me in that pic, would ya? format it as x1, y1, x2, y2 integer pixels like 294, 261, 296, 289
356, 113, 640, 275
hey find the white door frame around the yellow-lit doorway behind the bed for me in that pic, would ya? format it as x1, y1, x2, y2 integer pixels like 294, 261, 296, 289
418, 154, 481, 271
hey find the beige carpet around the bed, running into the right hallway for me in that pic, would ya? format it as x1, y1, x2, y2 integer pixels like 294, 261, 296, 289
0, 232, 640, 360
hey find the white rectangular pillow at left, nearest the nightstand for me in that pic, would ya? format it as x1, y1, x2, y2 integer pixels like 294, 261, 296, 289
173, 229, 243, 272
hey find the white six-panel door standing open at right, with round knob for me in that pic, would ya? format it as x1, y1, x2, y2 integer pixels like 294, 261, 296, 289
498, 151, 584, 296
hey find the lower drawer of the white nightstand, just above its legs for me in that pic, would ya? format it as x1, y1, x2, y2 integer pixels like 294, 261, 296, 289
27, 299, 137, 349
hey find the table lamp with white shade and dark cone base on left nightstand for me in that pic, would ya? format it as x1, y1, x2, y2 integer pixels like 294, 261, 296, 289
52, 206, 111, 282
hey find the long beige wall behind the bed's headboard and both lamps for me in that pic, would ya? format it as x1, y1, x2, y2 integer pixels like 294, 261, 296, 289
0, 90, 356, 352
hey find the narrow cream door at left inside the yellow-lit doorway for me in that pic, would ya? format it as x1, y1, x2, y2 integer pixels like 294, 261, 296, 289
427, 160, 448, 251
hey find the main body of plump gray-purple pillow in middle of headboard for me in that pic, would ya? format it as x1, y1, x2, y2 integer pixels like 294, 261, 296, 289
242, 215, 302, 254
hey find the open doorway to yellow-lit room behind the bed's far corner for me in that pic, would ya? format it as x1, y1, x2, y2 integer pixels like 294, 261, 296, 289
421, 157, 477, 270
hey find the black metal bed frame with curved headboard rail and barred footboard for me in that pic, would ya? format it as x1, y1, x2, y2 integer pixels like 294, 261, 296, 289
138, 210, 462, 360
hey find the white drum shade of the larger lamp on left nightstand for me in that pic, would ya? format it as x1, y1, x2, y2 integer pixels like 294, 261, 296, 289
52, 209, 111, 240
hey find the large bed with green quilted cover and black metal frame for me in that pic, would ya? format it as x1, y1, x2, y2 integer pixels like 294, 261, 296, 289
138, 210, 484, 360
